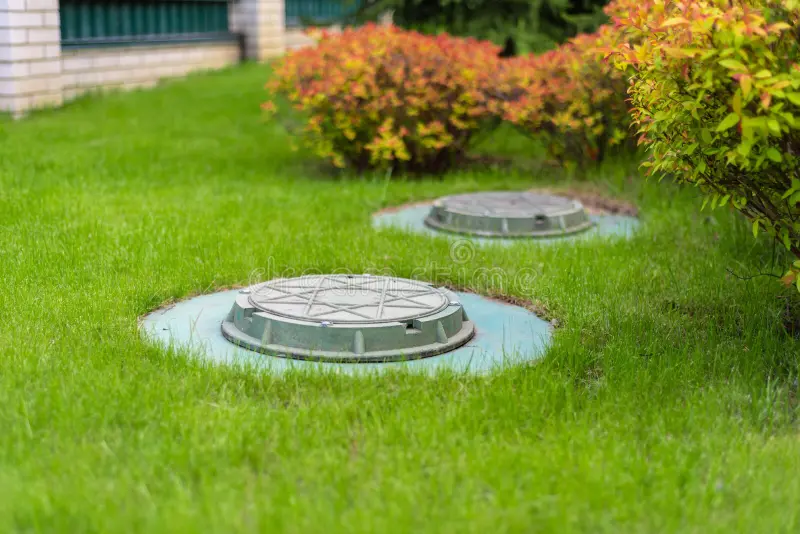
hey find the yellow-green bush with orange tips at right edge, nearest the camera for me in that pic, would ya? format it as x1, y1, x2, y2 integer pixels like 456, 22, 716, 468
611, 0, 800, 287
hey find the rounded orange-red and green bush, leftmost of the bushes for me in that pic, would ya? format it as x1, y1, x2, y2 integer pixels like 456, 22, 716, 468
265, 24, 500, 172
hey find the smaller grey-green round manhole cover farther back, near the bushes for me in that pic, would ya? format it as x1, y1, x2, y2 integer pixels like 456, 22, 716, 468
425, 192, 593, 237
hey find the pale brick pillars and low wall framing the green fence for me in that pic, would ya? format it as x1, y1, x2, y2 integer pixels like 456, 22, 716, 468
0, 0, 294, 115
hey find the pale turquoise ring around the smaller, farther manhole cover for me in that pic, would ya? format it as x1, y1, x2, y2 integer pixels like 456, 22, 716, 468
372, 201, 641, 245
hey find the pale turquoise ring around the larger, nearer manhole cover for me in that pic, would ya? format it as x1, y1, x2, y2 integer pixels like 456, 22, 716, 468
141, 290, 553, 375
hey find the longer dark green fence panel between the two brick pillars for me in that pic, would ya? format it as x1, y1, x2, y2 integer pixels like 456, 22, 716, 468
60, 0, 234, 47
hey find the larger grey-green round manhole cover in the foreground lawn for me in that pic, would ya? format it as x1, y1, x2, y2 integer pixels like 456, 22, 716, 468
222, 274, 475, 363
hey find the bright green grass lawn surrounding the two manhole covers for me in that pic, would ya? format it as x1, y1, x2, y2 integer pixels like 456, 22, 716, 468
0, 66, 800, 534
